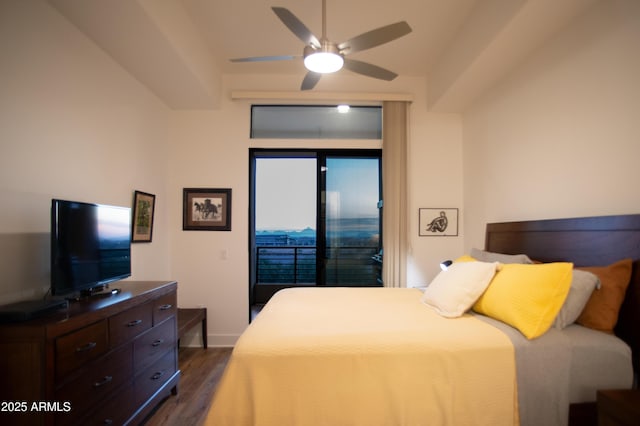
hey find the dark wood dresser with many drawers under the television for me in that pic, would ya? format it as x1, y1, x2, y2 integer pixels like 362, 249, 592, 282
0, 281, 180, 425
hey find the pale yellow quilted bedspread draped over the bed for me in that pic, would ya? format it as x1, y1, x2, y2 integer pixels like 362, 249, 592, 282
206, 288, 518, 426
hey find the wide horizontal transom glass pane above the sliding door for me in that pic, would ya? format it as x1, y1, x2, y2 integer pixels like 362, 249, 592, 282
251, 105, 382, 139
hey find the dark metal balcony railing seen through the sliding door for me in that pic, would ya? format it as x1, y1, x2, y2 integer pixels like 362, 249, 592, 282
256, 246, 380, 286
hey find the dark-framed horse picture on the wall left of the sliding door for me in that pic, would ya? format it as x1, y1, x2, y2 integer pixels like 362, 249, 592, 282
182, 188, 231, 231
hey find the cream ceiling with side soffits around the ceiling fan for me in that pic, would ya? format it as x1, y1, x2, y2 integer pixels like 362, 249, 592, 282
48, 0, 606, 111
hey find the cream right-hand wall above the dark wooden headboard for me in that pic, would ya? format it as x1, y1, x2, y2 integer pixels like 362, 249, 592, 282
463, 0, 640, 250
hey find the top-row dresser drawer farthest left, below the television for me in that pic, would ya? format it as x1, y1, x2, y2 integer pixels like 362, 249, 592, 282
56, 320, 109, 379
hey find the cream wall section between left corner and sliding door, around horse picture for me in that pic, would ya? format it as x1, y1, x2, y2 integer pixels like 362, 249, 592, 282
169, 100, 249, 345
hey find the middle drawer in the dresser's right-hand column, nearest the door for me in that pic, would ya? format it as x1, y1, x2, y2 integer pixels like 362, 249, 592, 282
133, 317, 176, 371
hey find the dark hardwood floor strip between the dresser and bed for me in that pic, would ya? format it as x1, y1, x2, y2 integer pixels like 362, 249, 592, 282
144, 348, 232, 426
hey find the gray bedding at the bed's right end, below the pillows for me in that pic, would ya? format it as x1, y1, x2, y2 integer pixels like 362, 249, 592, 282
473, 313, 633, 426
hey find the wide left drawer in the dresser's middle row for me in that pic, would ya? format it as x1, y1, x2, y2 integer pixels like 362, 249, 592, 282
56, 344, 133, 419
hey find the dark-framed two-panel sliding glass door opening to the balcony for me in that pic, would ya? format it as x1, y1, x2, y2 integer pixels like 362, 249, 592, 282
249, 149, 382, 304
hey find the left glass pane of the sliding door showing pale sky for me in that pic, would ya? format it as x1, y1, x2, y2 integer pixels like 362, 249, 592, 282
255, 158, 317, 284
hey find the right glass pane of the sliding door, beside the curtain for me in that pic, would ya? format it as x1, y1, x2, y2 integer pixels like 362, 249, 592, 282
324, 157, 380, 286
